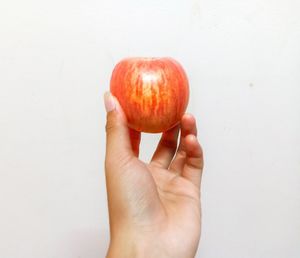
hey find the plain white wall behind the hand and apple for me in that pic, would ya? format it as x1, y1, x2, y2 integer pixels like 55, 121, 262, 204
0, 0, 300, 258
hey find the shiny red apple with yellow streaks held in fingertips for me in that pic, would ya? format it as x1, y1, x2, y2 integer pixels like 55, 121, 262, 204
110, 57, 189, 133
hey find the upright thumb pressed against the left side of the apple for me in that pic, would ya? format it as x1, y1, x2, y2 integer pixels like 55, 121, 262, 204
104, 92, 134, 166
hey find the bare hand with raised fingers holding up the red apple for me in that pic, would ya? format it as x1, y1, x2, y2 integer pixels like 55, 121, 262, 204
105, 93, 203, 258
